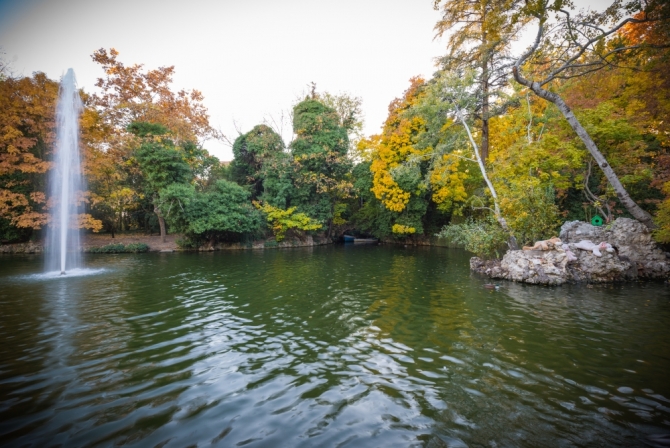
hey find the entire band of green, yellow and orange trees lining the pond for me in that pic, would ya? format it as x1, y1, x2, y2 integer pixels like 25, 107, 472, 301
0, 0, 670, 256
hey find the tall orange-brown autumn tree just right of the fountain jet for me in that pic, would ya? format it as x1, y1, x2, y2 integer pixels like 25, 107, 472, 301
87, 49, 221, 236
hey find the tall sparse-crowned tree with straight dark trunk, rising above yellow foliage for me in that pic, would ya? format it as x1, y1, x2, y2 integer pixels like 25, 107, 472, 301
434, 0, 520, 162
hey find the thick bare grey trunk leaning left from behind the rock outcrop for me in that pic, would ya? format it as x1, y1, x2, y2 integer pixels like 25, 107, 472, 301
514, 73, 656, 230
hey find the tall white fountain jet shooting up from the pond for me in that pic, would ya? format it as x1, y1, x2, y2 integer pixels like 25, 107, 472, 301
46, 69, 85, 275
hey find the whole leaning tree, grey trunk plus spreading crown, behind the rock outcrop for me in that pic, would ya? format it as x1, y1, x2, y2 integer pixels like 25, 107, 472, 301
513, 0, 668, 228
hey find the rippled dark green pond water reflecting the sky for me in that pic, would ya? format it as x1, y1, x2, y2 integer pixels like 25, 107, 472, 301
0, 245, 670, 447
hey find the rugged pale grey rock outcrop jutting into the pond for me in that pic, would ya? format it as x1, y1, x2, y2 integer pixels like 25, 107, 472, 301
470, 218, 670, 285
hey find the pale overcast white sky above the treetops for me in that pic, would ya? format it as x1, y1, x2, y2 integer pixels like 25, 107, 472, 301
0, 0, 608, 160
